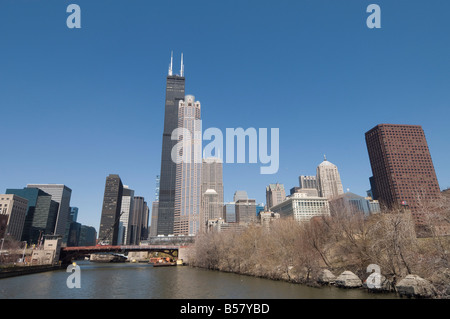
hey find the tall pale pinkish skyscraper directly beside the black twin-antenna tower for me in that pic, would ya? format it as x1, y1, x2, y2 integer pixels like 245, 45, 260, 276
174, 95, 202, 235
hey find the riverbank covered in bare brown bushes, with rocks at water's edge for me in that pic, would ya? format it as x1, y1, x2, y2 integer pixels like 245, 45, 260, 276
188, 215, 450, 299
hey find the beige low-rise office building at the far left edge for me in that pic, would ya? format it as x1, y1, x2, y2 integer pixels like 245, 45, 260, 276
0, 194, 28, 241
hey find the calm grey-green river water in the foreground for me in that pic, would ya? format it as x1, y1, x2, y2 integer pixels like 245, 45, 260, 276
0, 261, 396, 299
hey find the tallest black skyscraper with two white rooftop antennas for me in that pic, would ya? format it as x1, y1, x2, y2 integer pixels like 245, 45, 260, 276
157, 55, 185, 235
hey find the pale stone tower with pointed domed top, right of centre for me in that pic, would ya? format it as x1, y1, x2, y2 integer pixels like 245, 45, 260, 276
316, 156, 344, 199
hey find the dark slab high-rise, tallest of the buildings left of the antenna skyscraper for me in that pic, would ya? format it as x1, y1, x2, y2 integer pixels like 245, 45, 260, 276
98, 174, 123, 245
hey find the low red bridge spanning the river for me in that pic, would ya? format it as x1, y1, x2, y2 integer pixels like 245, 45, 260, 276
60, 245, 186, 264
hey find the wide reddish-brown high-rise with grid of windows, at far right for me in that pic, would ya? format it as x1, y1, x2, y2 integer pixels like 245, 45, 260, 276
365, 124, 440, 224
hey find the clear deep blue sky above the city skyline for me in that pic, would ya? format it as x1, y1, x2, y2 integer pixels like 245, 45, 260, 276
0, 0, 450, 229
